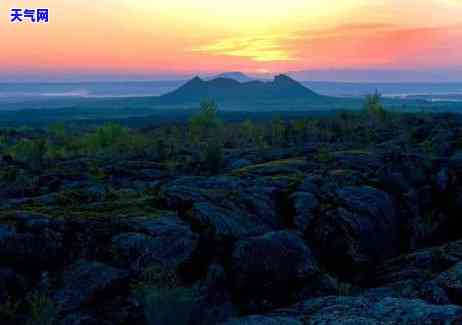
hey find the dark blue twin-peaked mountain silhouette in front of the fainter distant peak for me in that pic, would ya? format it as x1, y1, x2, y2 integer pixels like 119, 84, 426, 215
159, 75, 325, 104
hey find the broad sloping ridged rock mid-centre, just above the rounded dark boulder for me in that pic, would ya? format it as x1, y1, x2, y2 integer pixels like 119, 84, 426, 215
162, 176, 286, 238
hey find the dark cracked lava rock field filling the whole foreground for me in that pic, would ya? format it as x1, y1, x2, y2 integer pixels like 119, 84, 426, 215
0, 112, 462, 325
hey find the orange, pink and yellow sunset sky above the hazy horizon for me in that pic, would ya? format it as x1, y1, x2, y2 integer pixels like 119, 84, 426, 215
0, 0, 462, 81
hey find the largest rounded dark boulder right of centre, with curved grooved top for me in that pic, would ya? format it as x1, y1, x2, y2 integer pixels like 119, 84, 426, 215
308, 186, 400, 275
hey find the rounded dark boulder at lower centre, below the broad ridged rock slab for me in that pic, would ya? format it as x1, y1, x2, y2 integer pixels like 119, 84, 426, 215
232, 231, 319, 307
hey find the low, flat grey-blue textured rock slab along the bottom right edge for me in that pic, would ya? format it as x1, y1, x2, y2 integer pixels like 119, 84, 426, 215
226, 296, 462, 325
